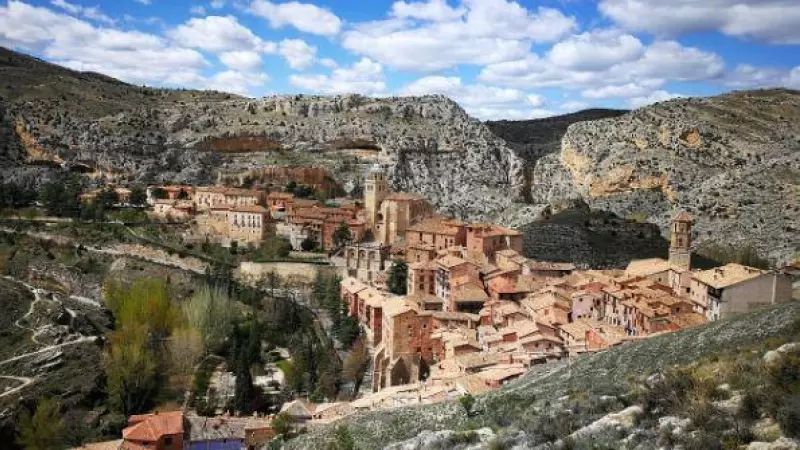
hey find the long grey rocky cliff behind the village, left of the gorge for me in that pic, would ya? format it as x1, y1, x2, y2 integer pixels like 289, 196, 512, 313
0, 46, 524, 218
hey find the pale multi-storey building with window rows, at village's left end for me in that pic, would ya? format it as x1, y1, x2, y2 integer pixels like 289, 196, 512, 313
197, 205, 271, 246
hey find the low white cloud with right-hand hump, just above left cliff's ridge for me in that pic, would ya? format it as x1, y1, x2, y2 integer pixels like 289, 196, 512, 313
289, 58, 386, 95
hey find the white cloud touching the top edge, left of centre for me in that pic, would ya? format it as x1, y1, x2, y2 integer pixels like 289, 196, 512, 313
249, 0, 342, 36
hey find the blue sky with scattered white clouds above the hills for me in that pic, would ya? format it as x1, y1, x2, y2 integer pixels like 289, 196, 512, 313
0, 0, 800, 120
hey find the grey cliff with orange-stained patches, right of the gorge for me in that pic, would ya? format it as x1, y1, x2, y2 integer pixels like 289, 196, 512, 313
531, 90, 800, 263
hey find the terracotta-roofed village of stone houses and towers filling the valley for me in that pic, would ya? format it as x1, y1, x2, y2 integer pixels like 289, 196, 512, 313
69, 166, 792, 450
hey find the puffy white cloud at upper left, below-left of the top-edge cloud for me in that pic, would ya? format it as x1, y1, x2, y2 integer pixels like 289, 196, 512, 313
167, 16, 264, 53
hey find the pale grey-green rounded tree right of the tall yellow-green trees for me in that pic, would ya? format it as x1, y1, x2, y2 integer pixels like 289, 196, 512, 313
183, 285, 235, 353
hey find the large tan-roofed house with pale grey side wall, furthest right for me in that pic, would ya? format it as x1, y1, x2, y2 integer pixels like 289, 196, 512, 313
690, 264, 792, 320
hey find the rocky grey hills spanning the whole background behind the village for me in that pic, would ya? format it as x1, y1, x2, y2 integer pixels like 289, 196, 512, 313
0, 48, 800, 265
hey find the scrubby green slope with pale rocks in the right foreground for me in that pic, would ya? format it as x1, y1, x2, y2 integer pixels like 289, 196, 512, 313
287, 302, 800, 450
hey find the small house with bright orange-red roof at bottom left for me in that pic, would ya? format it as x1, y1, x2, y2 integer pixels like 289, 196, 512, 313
121, 411, 184, 450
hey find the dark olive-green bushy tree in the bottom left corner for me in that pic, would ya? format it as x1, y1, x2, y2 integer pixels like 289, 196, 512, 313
17, 398, 64, 450
